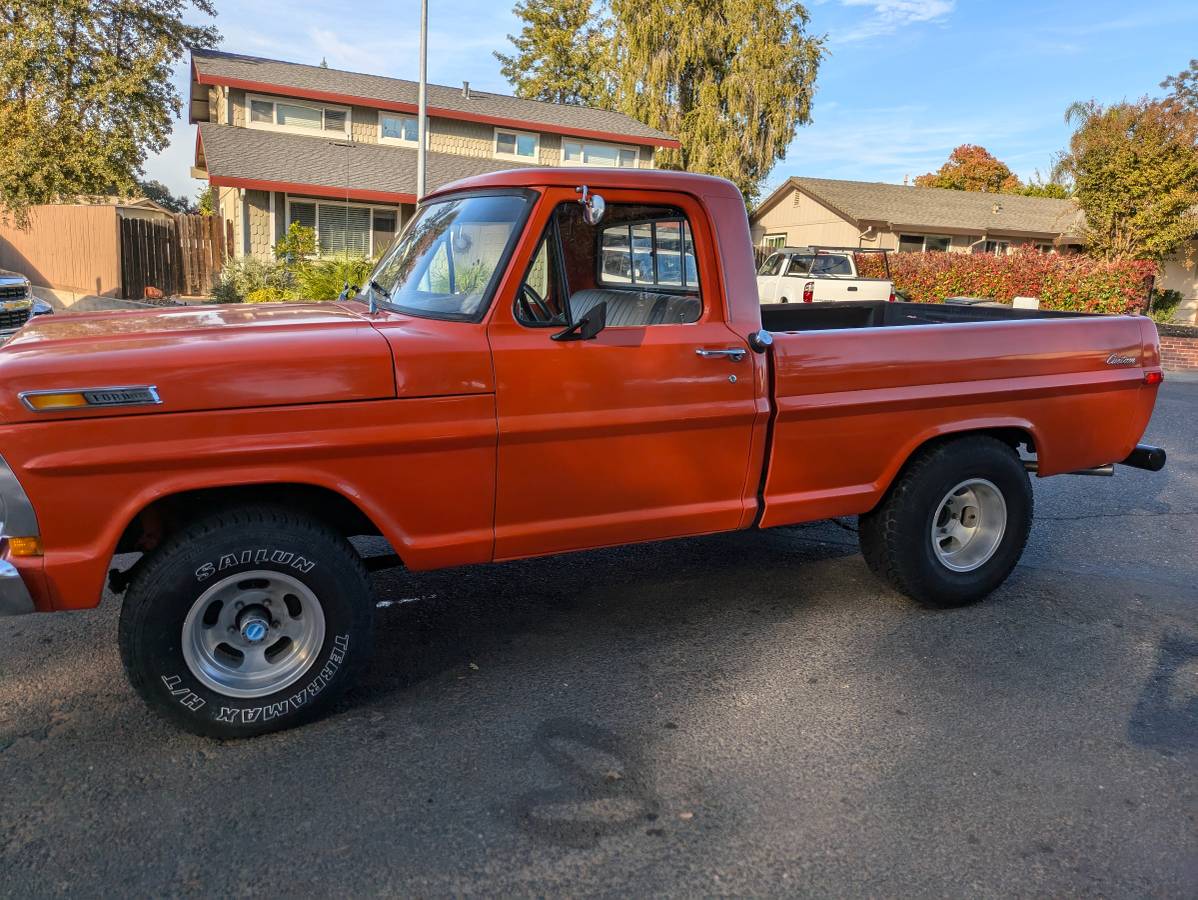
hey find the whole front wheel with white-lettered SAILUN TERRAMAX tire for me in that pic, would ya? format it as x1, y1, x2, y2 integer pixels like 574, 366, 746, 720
120, 506, 374, 738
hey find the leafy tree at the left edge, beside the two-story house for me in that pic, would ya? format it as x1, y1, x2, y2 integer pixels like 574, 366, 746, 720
0, 0, 218, 222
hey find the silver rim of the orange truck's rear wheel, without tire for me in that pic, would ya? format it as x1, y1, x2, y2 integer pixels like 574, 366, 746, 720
932, 478, 1006, 572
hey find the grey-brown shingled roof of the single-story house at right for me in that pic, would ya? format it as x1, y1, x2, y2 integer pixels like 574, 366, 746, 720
762, 177, 1082, 236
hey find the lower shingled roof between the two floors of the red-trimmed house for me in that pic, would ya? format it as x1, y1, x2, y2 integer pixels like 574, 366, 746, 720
199, 122, 525, 203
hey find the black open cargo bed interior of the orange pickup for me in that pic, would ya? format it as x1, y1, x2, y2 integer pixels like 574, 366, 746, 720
761, 301, 1089, 332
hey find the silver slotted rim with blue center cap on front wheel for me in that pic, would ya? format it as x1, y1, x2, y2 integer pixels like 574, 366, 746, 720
182, 570, 325, 697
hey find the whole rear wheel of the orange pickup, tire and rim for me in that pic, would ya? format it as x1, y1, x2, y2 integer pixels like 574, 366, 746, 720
859, 435, 1033, 606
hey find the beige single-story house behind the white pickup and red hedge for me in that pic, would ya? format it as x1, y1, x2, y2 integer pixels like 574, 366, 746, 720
750, 177, 1198, 312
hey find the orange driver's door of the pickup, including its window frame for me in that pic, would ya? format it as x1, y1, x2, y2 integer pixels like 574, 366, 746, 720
488, 188, 764, 558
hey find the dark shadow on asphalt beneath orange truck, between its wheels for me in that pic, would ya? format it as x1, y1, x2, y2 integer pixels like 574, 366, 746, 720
351, 527, 862, 703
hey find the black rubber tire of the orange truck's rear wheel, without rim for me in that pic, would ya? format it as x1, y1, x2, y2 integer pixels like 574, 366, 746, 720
858, 435, 1033, 608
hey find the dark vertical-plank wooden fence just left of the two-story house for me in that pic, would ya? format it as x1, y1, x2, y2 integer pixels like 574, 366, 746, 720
121, 216, 232, 300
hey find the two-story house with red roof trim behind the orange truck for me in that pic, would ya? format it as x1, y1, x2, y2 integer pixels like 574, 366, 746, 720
190, 50, 678, 255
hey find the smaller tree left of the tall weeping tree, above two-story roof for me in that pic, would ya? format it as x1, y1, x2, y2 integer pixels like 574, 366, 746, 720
495, 0, 611, 107
